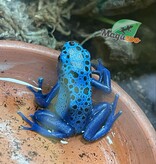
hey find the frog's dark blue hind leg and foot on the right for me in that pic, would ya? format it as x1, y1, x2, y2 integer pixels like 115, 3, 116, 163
83, 95, 122, 141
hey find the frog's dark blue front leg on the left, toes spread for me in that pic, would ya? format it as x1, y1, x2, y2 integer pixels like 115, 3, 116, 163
28, 77, 59, 108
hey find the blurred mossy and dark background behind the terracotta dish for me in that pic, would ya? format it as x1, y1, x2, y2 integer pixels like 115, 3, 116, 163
0, 0, 156, 128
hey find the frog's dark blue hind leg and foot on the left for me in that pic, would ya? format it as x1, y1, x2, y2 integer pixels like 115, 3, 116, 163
17, 110, 74, 139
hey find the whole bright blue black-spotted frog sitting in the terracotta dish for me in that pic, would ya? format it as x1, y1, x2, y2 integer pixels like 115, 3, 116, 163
18, 41, 122, 142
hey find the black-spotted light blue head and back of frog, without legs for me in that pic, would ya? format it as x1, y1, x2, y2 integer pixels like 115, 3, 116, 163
56, 42, 92, 133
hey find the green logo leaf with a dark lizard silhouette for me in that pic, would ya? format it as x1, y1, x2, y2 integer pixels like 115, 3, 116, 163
112, 19, 141, 37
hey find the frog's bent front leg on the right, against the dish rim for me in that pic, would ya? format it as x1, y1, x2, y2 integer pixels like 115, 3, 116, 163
91, 59, 111, 93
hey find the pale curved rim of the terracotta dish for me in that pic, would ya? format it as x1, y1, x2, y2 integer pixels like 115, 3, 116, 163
0, 40, 156, 161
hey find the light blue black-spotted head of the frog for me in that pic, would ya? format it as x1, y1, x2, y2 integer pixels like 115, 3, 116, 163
58, 41, 90, 72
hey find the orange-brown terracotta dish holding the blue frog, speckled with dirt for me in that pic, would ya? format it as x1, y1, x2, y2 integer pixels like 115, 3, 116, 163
0, 41, 156, 164
